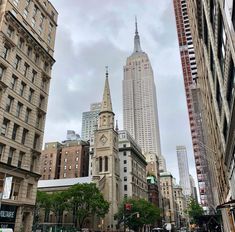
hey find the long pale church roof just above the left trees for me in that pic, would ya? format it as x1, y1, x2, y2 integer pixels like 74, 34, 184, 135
38, 176, 92, 188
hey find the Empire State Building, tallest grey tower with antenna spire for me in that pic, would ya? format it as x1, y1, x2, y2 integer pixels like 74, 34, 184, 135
123, 19, 161, 158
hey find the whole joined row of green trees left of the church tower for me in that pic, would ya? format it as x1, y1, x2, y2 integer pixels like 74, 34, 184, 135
36, 183, 109, 228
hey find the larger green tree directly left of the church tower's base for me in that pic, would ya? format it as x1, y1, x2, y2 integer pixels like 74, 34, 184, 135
68, 183, 109, 228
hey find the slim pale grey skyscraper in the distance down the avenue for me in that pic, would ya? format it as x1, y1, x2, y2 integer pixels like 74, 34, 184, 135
176, 146, 192, 197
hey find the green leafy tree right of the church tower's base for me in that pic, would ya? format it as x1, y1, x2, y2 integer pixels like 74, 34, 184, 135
115, 198, 160, 231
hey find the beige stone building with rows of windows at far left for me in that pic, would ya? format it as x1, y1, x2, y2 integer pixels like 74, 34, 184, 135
0, 0, 58, 232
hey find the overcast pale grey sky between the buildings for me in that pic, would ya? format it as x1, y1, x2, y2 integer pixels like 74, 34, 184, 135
44, 0, 196, 184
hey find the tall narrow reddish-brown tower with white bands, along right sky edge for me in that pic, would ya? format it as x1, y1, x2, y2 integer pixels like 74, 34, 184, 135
173, 0, 214, 211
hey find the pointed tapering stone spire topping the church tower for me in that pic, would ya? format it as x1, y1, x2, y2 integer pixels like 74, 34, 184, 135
100, 66, 113, 114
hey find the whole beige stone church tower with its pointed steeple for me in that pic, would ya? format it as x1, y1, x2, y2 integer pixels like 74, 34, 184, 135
92, 70, 121, 230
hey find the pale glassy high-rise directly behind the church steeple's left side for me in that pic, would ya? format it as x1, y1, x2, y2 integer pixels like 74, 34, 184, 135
82, 102, 101, 141
